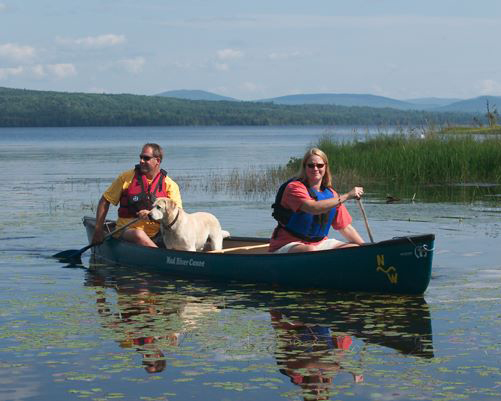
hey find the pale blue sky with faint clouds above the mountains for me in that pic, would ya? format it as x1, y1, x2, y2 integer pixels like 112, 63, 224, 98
0, 0, 501, 100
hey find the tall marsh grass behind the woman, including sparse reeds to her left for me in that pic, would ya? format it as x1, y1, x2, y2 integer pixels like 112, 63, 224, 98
196, 129, 501, 202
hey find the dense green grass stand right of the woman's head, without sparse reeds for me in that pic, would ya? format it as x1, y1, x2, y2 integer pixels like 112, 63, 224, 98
304, 134, 501, 184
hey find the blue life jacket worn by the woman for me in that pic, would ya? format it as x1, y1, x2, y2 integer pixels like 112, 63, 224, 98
271, 178, 337, 242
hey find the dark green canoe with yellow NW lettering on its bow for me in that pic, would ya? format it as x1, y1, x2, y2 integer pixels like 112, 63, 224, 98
83, 217, 435, 294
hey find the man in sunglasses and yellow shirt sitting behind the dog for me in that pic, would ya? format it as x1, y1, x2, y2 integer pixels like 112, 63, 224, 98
92, 143, 183, 248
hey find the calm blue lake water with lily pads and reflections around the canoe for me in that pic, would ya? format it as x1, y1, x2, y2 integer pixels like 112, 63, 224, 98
0, 127, 501, 401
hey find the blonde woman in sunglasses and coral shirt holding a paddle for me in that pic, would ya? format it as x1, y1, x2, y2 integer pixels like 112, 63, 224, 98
269, 148, 364, 253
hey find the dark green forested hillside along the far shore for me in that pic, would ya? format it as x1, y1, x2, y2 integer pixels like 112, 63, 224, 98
0, 88, 484, 127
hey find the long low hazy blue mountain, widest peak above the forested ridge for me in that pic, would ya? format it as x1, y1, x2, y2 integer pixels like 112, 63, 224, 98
254, 93, 421, 110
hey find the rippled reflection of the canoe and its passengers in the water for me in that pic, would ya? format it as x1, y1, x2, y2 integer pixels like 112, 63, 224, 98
85, 261, 433, 384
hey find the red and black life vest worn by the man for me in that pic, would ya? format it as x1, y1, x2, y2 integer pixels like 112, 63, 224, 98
118, 165, 168, 218
